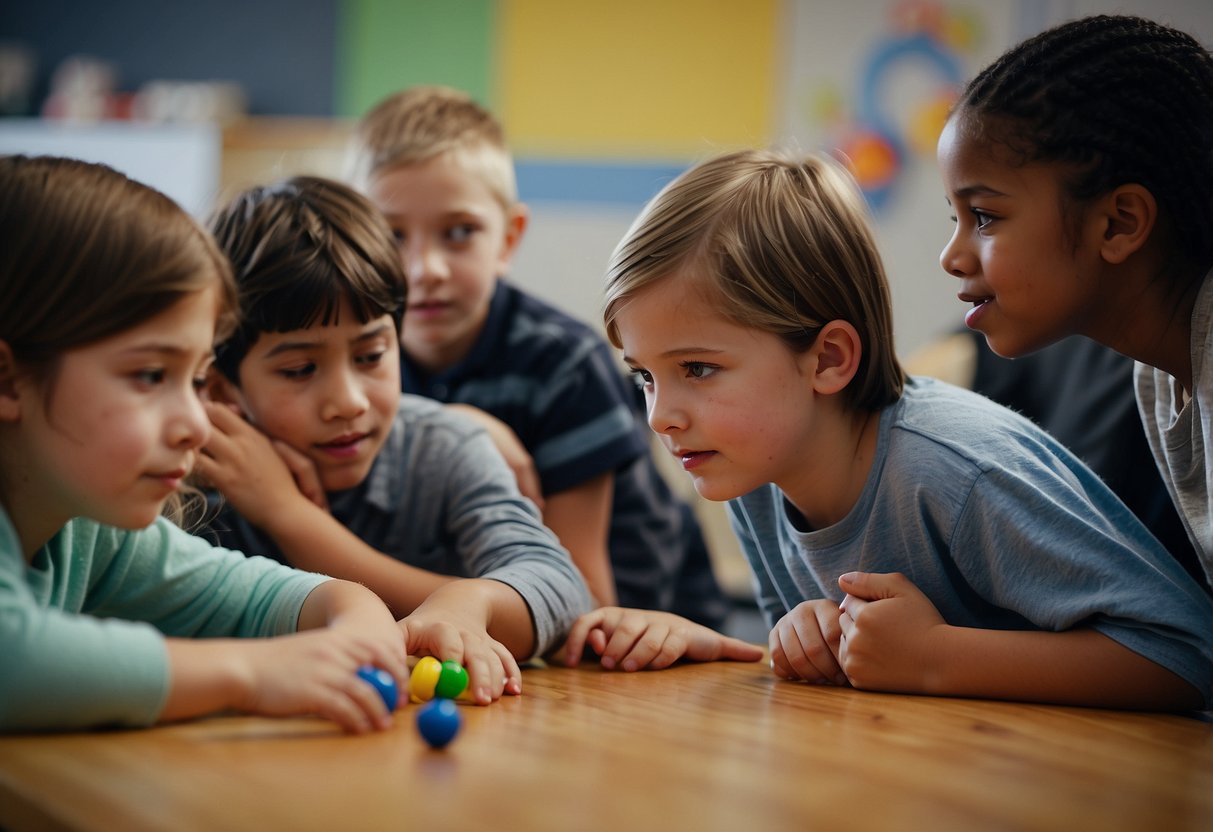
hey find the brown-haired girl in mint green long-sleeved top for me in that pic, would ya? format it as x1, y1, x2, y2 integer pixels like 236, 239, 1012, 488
0, 156, 412, 731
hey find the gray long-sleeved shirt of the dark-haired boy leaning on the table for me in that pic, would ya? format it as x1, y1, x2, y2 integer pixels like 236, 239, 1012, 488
203, 394, 590, 654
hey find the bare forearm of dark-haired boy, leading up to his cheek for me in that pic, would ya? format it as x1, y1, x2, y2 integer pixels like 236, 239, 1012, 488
263, 497, 455, 619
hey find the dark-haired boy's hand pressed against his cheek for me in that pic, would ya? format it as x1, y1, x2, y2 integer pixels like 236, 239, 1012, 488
198, 403, 323, 529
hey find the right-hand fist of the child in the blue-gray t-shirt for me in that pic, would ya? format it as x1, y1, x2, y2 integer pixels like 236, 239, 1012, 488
838, 572, 946, 693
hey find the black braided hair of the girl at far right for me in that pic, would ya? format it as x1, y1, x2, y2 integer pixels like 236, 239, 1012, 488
956, 15, 1213, 275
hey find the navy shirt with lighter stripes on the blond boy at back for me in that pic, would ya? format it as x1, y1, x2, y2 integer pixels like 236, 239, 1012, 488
400, 280, 728, 627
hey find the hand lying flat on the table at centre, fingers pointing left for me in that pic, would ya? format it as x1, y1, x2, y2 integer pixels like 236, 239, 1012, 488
563, 606, 763, 671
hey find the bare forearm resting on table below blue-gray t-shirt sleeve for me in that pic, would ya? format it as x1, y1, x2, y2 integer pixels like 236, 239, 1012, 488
912, 627, 1203, 711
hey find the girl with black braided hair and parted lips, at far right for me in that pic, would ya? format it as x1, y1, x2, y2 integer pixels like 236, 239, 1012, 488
939, 16, 1213, 594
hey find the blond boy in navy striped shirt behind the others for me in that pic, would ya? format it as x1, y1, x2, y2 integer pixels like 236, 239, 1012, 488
355, 87, 728, 626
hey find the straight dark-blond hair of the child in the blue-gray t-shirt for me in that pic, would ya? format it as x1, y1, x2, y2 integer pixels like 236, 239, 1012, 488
603, 150, 905, 410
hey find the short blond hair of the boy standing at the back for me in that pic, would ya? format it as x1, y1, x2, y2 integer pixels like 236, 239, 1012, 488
351, 86, 518, 210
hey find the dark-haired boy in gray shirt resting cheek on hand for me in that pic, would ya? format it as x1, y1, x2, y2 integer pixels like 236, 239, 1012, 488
199, 177, 590, 688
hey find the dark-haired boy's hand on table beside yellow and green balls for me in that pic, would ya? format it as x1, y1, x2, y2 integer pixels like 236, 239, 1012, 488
399, 595, 523, 705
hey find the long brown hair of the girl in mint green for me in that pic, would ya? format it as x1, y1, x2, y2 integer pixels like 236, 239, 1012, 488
0, 155, 237, 523
